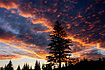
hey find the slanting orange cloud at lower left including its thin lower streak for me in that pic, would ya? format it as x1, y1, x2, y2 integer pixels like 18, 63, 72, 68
0, 39, 47, 59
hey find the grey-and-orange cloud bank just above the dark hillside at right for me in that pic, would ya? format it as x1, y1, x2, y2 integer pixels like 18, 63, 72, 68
71, 46, 105, 60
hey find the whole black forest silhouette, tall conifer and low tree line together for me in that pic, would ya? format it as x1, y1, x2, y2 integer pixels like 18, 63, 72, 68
0, 21, 105, 70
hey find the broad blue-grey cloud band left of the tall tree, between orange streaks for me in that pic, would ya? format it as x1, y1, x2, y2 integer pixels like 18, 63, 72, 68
0, 6, 49, 46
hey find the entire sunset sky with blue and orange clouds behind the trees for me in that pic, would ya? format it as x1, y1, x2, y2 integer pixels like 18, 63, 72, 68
0, 0, 105, 68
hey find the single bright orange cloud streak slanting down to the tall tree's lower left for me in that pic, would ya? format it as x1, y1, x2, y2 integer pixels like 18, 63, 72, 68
0, 38, 47, 59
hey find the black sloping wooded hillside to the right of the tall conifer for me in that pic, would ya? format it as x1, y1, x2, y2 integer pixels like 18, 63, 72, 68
53, 58, 105, 70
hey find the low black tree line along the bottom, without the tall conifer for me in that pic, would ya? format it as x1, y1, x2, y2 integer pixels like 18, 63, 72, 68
0, 58, 105, 70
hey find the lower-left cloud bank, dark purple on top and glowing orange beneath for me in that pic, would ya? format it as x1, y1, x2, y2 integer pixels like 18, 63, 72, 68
0, 26, 47, 60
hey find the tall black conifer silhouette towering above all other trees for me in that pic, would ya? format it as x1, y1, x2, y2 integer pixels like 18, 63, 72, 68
47, 21, 72, 69
